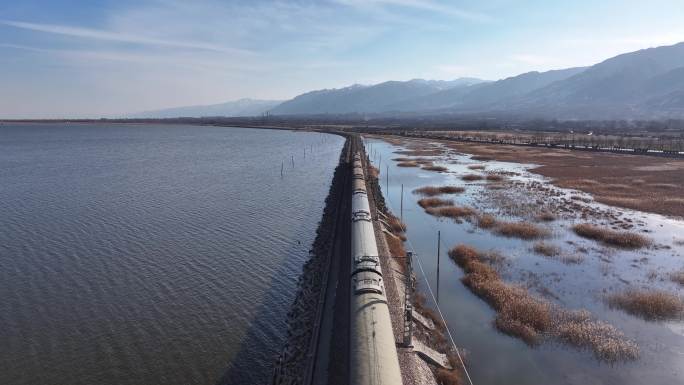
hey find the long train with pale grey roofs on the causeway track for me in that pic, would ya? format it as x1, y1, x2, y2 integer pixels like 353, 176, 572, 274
349, 153, 401, 385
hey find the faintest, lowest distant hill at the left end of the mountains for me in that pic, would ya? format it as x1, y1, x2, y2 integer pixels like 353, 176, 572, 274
130, 99, 281, 118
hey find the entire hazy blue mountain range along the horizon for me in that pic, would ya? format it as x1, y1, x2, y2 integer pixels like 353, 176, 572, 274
135, 43, 684, 119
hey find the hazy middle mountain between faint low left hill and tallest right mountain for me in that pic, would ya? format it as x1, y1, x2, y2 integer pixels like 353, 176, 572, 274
270, 78, 483, 115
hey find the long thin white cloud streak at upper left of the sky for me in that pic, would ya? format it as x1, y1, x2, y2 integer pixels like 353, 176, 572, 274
0, 20, 251, 54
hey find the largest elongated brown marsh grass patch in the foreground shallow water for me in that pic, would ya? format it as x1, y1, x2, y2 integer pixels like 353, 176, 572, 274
449, 245, 639, 362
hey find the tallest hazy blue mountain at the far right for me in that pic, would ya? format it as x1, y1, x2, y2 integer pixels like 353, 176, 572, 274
508, 43, 684, 119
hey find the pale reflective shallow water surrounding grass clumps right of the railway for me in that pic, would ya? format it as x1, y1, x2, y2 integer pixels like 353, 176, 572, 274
366, 139, 684, 385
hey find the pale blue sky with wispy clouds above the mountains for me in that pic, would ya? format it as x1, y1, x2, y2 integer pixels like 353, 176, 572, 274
0, 0, 684, 118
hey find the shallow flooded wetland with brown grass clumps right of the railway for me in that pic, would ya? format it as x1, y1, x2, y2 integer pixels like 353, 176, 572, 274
365, 137, 684, 384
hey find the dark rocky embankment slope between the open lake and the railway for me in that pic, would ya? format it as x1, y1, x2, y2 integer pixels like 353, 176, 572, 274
272, 138, 351, 384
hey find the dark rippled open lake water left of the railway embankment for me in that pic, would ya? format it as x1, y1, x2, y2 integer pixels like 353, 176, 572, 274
0, 124, 343, 385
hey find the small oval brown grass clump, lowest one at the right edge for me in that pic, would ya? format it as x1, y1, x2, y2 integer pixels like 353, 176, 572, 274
607, 289, 684, 321
